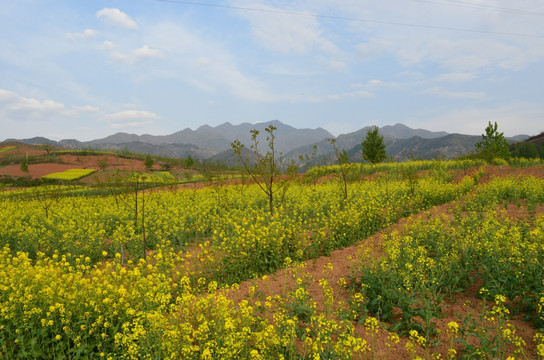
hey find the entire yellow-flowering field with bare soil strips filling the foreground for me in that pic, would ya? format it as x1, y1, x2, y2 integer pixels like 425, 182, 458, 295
0, 160, 544, 359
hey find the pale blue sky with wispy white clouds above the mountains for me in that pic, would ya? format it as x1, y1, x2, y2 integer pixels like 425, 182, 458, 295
0, 0, 544, 141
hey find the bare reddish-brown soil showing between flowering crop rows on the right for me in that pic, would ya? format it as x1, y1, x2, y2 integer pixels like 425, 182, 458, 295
225, 166, 544, 360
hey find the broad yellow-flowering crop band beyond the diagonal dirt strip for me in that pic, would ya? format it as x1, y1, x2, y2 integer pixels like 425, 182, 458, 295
0, 164, 475, 283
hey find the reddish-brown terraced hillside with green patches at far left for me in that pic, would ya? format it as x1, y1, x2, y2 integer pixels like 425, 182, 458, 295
0, 142, 217, 189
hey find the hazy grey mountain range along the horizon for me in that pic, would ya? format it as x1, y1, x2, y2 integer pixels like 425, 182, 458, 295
2, 120, 528, 164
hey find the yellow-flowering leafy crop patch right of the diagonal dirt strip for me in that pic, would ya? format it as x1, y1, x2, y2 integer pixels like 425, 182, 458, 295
353, 177, 544, 350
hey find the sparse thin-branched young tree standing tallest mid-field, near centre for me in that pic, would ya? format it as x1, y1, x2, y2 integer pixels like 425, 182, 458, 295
231, 125, 296, 216
